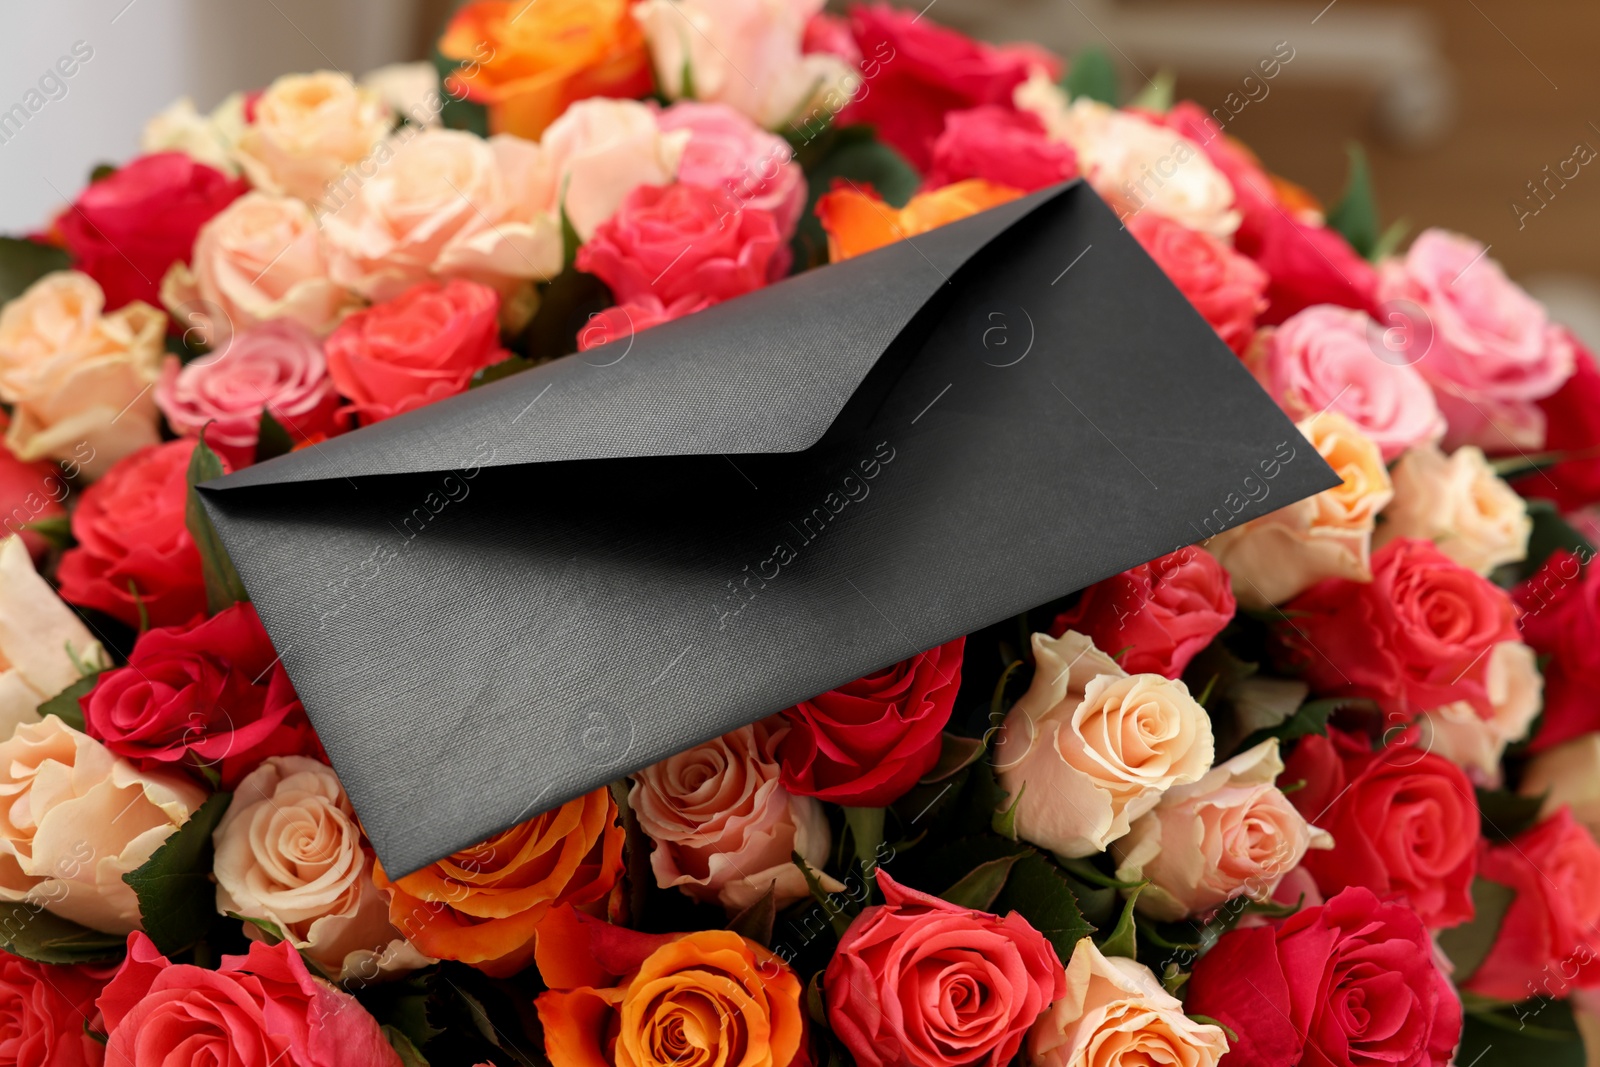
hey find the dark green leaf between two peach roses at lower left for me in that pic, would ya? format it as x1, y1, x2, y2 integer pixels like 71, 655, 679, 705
122, 793, 232, 955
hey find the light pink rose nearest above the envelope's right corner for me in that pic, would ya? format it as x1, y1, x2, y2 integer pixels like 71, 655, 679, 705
1250, 306, 1445, 459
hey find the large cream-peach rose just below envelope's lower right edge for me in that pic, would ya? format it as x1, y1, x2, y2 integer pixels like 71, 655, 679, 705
994, 630, 1213, 857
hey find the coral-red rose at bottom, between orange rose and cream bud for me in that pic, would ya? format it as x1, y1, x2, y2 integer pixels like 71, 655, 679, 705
822, 869, 1067, 1067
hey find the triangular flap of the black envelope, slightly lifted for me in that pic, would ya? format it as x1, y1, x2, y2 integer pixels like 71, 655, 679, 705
208, 182, 1062, 490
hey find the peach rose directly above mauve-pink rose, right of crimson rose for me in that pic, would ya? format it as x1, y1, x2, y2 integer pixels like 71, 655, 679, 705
162, 192, 358, 340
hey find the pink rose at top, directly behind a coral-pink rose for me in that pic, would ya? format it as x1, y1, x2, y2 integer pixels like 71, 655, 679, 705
656, 101, 806, 240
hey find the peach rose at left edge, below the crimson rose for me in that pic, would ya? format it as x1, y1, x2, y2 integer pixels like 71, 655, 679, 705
0, 270, 166, 478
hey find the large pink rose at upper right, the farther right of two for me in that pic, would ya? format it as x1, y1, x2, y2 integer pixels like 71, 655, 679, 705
1378, 230, 1574, 451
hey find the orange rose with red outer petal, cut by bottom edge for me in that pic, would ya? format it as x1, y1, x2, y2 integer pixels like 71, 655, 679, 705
534, 929, 805, 1067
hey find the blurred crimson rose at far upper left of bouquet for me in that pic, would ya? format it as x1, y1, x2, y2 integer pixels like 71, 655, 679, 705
56, 152, 248, 310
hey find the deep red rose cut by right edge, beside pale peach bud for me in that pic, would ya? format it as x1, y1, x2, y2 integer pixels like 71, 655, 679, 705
1517, 549, 1600, 752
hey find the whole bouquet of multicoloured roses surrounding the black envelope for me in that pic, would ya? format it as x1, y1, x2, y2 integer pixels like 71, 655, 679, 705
0, 0, 1600, 1067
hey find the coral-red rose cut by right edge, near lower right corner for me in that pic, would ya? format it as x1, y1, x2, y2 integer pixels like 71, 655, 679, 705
1462, 806, 1600, 1001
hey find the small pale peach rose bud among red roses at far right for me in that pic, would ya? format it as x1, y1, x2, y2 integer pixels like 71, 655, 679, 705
1418, 641, 1544, 787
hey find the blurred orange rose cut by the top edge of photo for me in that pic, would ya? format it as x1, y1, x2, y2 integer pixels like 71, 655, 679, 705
438, 0, 651, 139
